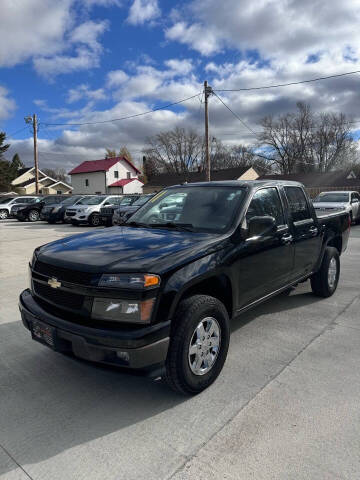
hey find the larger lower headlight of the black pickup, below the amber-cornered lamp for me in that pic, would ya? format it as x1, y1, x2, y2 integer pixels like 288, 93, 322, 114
91, 298, 155, 323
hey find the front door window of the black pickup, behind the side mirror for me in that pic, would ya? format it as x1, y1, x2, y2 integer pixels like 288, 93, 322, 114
246, 188, 285, 225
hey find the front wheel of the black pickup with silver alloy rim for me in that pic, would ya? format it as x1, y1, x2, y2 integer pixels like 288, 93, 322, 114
165, 295, 230, 395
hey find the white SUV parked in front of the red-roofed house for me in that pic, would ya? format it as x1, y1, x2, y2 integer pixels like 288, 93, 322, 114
64, 195, 119, 227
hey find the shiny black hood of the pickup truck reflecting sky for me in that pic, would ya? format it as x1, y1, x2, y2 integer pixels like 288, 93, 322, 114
38, 226, 224, 274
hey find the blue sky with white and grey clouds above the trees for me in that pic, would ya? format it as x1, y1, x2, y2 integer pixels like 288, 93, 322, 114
0, 0, 360, 170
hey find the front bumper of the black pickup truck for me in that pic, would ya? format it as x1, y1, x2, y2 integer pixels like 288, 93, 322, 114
19, 289, 170, 376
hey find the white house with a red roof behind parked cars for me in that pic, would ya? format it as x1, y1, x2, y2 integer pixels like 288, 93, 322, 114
69, 157, 143, 194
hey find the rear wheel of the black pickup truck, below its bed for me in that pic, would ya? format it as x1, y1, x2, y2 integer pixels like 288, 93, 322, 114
310, 247, 340, 298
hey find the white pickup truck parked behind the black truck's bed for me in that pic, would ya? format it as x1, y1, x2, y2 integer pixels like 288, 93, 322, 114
313, 191, 360, 223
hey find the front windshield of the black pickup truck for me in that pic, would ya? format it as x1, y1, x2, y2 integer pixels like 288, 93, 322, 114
128, 186, 246, 233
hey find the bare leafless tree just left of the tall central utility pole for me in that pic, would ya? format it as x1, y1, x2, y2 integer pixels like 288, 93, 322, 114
143, 128, 204, 174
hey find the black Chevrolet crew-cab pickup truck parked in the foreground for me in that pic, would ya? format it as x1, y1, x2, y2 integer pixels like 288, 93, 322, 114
20, 181, 350, 394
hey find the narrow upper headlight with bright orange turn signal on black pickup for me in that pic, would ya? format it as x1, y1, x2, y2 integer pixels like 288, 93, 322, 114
99, 273, 160, 290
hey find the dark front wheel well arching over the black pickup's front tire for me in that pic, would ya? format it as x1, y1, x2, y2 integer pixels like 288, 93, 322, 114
180, 274, 233, 318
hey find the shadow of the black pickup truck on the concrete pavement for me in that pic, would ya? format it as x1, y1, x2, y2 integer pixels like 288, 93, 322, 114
0, 284, 319, 475
